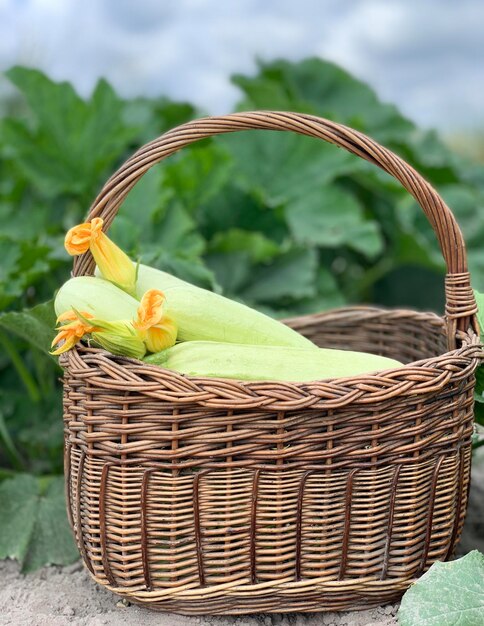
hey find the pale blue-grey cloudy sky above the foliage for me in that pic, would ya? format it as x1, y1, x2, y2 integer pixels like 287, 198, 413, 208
0, 0, 484, 131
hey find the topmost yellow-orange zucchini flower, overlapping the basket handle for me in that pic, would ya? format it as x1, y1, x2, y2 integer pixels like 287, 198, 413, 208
64, 217, 137, 295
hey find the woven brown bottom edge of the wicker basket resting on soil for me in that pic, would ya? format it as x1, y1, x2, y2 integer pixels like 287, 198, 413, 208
91, 574, 408, 615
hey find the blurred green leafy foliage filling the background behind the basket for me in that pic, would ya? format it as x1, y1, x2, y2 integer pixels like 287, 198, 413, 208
0, 59, 484, 569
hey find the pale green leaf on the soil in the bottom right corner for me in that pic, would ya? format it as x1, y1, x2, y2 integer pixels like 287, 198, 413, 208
398, 550, 484, 626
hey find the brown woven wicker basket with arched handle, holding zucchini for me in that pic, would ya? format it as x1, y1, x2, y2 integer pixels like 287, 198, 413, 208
62, 111, 482, 614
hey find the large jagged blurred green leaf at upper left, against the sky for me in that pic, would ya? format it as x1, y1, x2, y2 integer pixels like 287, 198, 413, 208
3, 67, 136, 198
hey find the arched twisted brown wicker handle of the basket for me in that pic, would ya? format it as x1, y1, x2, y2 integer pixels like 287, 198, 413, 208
73, 111, 479, 349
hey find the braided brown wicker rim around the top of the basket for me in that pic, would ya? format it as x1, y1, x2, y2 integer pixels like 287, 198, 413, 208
60, 307, 484, 411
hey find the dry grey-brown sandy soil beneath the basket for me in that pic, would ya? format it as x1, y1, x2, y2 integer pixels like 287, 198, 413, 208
0, 448, 484, 626
